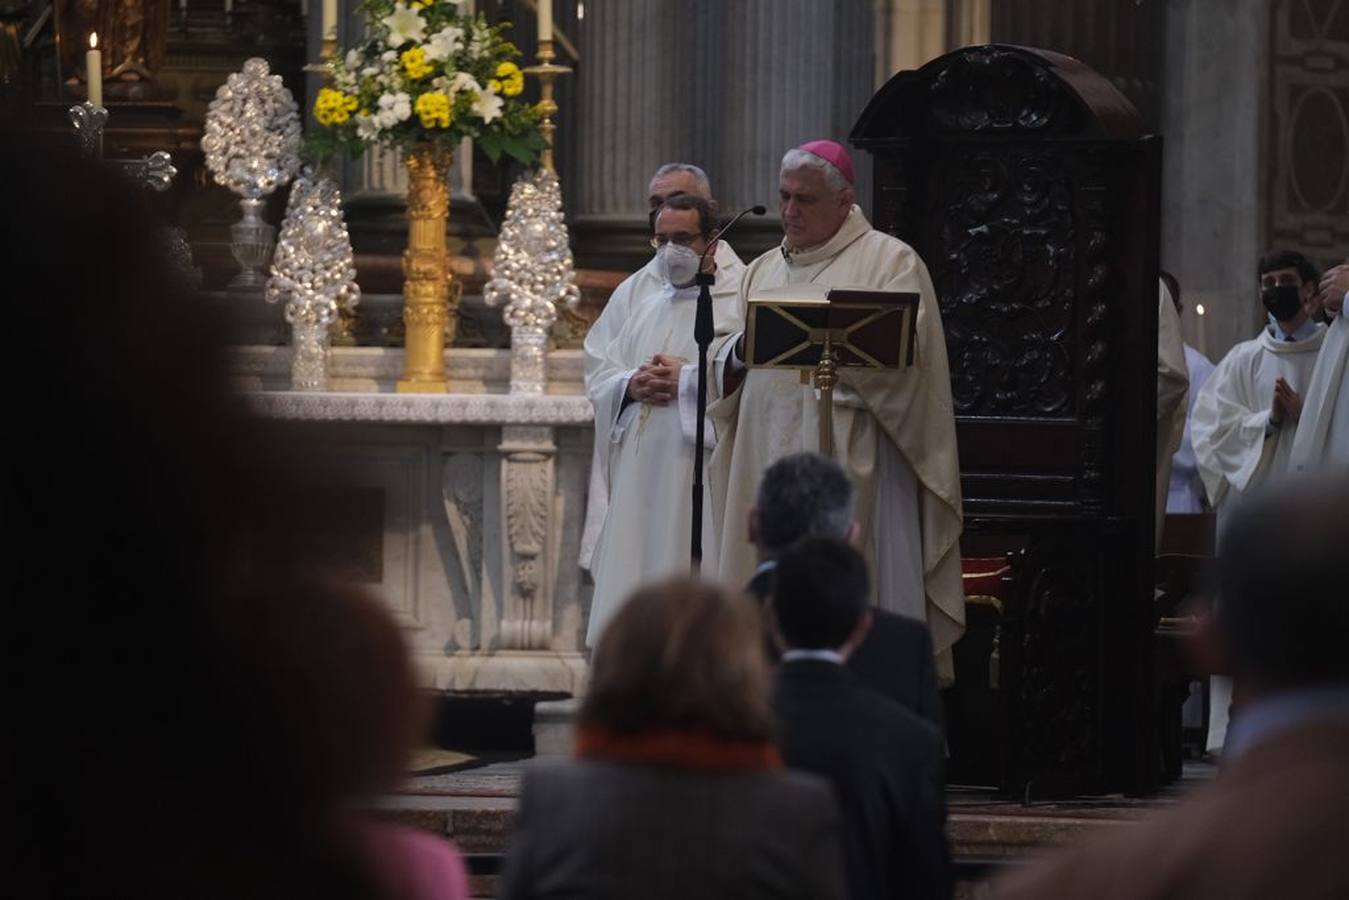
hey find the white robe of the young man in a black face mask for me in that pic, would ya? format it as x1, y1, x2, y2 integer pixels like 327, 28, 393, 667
1190, 328, 1326, 536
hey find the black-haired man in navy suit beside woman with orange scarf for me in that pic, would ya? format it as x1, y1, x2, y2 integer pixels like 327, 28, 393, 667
769, 538, 951, 900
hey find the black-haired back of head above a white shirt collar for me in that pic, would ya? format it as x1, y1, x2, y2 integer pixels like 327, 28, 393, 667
770, 537, 871, 658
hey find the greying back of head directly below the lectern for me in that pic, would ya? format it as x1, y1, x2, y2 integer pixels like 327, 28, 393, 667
749, 453, 858, 561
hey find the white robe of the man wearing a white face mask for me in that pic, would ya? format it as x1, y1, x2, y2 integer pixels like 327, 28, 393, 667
583, 247, 745, 646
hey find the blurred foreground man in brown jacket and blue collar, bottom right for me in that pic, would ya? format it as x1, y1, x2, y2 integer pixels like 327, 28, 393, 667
994, 483, 1349, 900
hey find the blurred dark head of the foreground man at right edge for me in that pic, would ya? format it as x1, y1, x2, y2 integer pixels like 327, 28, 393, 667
1214, 471, 1349, 707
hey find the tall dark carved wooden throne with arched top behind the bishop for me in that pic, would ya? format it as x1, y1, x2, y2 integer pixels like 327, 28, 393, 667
851, 46, 1161, 799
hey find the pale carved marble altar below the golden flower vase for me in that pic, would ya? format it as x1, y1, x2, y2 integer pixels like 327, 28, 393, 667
232, 345, 592, 696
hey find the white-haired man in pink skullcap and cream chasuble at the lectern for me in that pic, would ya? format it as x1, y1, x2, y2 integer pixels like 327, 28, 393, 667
710, 140, 965, 681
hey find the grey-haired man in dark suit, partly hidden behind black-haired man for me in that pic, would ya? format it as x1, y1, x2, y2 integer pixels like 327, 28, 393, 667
747, 453, 942, 729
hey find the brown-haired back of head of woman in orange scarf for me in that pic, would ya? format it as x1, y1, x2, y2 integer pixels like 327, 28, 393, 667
577, 579, 773, 758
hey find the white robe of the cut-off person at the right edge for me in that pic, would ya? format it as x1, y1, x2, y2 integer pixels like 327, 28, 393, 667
1288, 313, 1349, 474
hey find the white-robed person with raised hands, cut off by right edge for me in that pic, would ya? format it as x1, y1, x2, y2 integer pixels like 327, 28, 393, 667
1288, 263, 1349, 474
